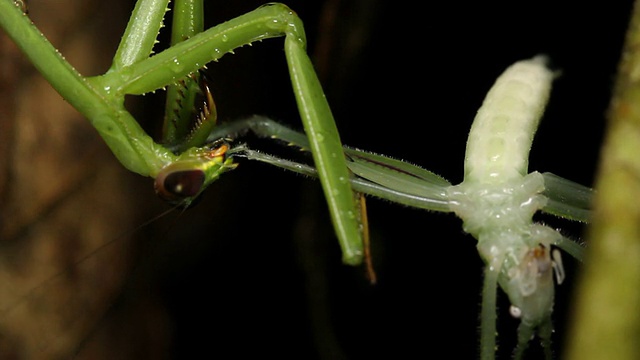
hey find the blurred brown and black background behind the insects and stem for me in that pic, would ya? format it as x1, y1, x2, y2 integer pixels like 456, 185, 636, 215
0, 0, 630, 359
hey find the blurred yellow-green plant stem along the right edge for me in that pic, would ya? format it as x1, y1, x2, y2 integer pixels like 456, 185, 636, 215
564, 1, 640, 360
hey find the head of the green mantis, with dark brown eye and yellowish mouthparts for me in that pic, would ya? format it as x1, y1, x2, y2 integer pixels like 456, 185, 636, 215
154, 140, 237, 207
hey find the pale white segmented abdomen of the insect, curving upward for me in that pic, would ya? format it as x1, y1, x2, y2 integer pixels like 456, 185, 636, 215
464, 56, 554, 183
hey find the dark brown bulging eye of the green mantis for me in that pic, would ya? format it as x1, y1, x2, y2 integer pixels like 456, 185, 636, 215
155, 163, 205, 205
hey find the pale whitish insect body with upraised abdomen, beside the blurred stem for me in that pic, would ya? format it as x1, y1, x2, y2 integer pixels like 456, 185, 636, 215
447, 56, 580, 357
